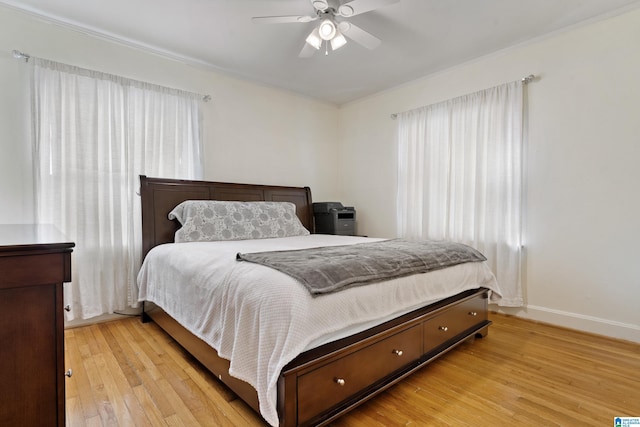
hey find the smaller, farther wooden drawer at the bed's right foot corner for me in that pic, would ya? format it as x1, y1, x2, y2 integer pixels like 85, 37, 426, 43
423, 295, 488, 353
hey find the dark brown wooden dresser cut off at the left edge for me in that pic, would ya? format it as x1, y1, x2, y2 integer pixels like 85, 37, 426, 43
0, 224, 74, 427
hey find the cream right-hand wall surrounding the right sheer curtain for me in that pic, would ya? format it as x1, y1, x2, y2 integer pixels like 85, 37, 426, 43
340, 6, 640, 342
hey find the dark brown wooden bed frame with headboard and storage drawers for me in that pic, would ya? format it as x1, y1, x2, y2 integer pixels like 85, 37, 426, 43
140, 175, 491, 427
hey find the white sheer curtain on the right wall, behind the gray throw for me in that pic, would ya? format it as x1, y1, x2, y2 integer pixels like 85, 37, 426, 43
398, 82, 524, 306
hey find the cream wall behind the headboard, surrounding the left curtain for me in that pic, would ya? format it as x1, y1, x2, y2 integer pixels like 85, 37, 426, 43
0, 6, 339, 224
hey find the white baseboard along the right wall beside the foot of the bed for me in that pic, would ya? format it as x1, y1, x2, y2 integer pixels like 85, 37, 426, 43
490, 305, 640, 343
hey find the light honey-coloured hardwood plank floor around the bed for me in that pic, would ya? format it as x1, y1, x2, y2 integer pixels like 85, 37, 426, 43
65, 314, 640, 427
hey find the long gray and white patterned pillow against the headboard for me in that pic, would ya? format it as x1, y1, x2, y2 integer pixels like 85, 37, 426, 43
169, 200, 309, 243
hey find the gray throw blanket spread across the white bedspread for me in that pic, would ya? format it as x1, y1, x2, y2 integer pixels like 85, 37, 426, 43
236, 239, 486, 297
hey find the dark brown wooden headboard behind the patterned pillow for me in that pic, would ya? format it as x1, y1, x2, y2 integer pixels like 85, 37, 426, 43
140, 175, 314, 259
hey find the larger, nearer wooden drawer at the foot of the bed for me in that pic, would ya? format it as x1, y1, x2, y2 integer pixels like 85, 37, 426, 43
297, 325, 422, 424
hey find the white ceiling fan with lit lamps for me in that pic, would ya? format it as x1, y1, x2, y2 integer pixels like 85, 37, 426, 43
252, 0, 400, 58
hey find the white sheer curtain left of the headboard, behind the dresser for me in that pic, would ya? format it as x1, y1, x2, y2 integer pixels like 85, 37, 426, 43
32, 58, 202, 320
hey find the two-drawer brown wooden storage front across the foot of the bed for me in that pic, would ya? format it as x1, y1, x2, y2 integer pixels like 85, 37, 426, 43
296, 292, 490, 425
